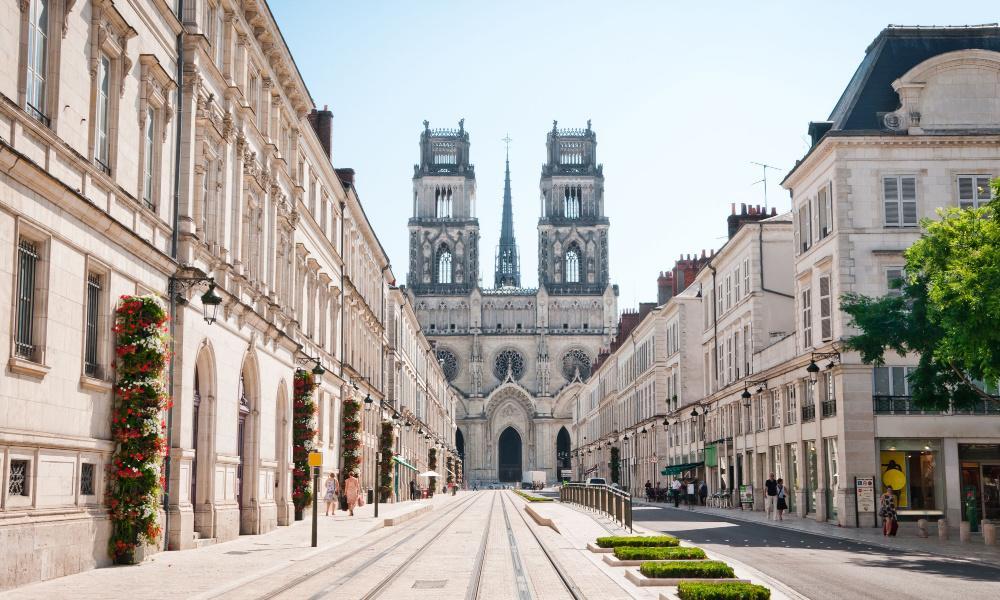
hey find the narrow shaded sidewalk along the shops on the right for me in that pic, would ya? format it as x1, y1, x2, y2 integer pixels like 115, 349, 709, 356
632, 498, 1000, 566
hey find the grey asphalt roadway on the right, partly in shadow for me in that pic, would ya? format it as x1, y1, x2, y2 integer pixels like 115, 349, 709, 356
634, 506, 1000, 600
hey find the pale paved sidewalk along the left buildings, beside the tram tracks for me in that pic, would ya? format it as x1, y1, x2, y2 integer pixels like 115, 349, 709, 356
0, 493, 465, 600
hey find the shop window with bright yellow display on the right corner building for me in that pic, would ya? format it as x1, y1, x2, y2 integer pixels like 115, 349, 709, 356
879, 440, 944, 514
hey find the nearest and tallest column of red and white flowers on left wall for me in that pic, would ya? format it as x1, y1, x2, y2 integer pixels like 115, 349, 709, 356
107, 295, 171, 564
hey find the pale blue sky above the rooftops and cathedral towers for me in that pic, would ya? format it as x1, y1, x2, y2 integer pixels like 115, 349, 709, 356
270, 0, 1000, 308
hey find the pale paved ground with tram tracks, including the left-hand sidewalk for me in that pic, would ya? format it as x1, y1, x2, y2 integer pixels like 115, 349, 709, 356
0, 491, 658, 600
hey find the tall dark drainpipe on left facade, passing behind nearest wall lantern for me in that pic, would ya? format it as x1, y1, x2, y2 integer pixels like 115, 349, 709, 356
163, 0, 184, 550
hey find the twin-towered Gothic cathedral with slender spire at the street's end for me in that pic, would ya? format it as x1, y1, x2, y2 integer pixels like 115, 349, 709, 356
408, 121, 618, 482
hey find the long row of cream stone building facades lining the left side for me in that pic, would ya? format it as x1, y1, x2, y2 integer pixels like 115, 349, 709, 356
0, 0, 454, 588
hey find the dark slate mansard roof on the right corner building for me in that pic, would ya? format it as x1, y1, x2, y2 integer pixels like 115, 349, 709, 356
828, 23, 1000, 131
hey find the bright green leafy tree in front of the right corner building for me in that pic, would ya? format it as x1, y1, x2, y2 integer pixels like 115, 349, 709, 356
841, 179, 1000, 409
